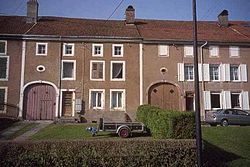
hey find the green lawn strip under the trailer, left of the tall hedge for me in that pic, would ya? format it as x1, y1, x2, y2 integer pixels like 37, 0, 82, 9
30, 124, 115, 140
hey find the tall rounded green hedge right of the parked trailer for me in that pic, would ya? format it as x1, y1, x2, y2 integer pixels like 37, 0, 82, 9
136, 105, 195, 139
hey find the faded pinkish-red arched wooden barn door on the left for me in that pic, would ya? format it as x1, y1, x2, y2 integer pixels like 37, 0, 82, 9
23, 83, 56, 120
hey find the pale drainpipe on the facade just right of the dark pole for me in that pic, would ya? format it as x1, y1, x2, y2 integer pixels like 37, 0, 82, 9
200, 41, 207, 121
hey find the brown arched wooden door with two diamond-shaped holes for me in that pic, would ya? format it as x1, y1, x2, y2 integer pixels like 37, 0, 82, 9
148, 83, 180, 110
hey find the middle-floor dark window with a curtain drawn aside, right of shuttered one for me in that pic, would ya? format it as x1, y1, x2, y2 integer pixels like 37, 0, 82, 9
111, 61, 125, 81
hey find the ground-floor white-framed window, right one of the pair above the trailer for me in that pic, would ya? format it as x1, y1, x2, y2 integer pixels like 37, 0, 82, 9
110, 89, 125, 110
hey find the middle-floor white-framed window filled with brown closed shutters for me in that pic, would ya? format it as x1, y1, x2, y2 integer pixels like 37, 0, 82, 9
90, 61, 105, 81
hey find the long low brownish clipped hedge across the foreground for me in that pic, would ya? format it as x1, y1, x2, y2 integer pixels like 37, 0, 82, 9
0, 139, 196, 167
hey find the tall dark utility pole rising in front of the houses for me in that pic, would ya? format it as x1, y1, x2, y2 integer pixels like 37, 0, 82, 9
193, 0, 202, 167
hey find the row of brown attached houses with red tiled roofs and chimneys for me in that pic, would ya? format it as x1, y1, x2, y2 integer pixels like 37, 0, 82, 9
0, 0, 250, 121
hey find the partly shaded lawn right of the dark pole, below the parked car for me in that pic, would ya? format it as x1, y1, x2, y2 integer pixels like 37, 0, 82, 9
202, 126, 250, 167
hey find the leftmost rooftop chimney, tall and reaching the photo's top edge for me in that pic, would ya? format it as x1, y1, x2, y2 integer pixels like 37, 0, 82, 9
26, 0, 39, 23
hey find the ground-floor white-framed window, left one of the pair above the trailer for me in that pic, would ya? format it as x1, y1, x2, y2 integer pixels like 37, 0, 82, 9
89, 89, 105, 109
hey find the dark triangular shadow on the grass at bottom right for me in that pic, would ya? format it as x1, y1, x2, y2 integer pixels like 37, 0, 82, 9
203, 141, 242, 167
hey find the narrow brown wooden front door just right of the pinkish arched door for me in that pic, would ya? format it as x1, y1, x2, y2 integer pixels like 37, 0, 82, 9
62, 91, 73, 117
